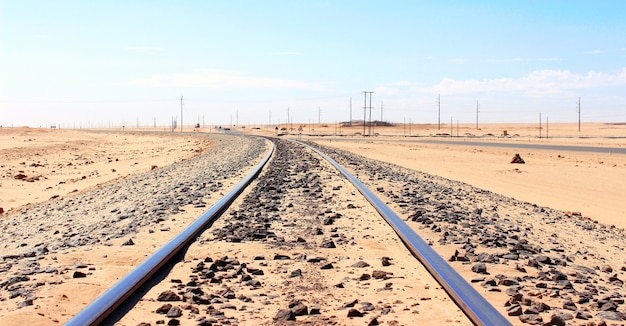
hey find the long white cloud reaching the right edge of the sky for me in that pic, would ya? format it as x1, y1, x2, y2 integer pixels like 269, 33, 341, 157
432, 68, 626, 96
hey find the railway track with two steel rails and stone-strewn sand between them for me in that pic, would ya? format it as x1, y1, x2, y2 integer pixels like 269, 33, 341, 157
67, 140, 509, 325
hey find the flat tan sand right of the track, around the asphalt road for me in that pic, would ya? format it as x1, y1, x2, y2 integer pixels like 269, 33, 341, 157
244, 123, 626, 228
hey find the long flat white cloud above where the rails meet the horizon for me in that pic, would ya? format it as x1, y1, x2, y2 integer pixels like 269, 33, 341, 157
123, 69, 325, 91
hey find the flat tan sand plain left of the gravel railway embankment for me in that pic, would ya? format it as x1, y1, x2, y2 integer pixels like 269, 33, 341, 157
0, 128, 212, 212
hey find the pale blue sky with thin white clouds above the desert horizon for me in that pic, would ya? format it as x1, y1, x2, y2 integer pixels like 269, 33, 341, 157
0, 0, 626, 127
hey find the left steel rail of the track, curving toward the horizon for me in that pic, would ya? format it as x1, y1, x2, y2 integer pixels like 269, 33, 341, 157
65, 142, 274, 326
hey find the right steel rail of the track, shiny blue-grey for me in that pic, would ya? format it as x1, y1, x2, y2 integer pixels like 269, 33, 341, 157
295, 141, 511, 326
